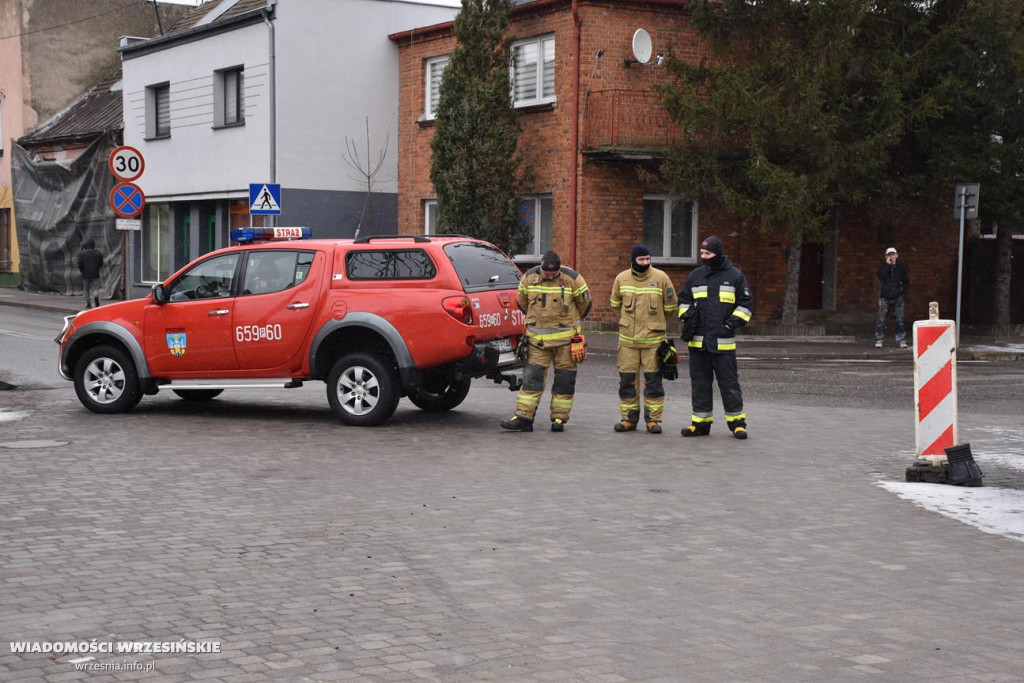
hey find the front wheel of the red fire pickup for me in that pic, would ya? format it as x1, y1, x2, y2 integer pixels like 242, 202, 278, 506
74, 345, 142, 413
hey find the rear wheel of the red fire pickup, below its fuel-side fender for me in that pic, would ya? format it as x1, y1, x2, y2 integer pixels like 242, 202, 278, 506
327, 353, 398, 427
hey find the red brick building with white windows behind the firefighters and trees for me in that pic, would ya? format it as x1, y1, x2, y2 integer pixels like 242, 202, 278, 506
390, 0, 956, 331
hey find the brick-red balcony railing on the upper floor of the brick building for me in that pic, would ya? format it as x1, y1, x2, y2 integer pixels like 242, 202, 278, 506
583, 88, 683, 160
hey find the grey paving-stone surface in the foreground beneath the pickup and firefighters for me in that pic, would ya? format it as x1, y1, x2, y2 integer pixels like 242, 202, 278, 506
0, 383, 1024, 683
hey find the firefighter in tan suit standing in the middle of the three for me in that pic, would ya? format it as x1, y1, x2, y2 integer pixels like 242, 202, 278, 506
611, 245, 679, 434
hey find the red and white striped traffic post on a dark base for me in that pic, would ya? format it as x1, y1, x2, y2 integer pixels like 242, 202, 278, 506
913, 303, 957, 466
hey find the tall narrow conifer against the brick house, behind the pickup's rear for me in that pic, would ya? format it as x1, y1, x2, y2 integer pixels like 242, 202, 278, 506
430, 0, 527, 254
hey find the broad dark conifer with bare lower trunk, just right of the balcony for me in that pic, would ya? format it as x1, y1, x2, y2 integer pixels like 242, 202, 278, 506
662, 0, 920, 325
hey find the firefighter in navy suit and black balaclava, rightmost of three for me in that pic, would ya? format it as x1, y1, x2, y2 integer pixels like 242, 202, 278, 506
679, 237, 754, 438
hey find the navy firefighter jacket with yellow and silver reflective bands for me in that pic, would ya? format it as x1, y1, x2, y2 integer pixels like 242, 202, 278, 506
679, 256, 754, 353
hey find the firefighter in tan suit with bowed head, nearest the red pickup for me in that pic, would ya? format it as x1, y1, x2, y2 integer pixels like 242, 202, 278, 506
502, 252, 593, 432
